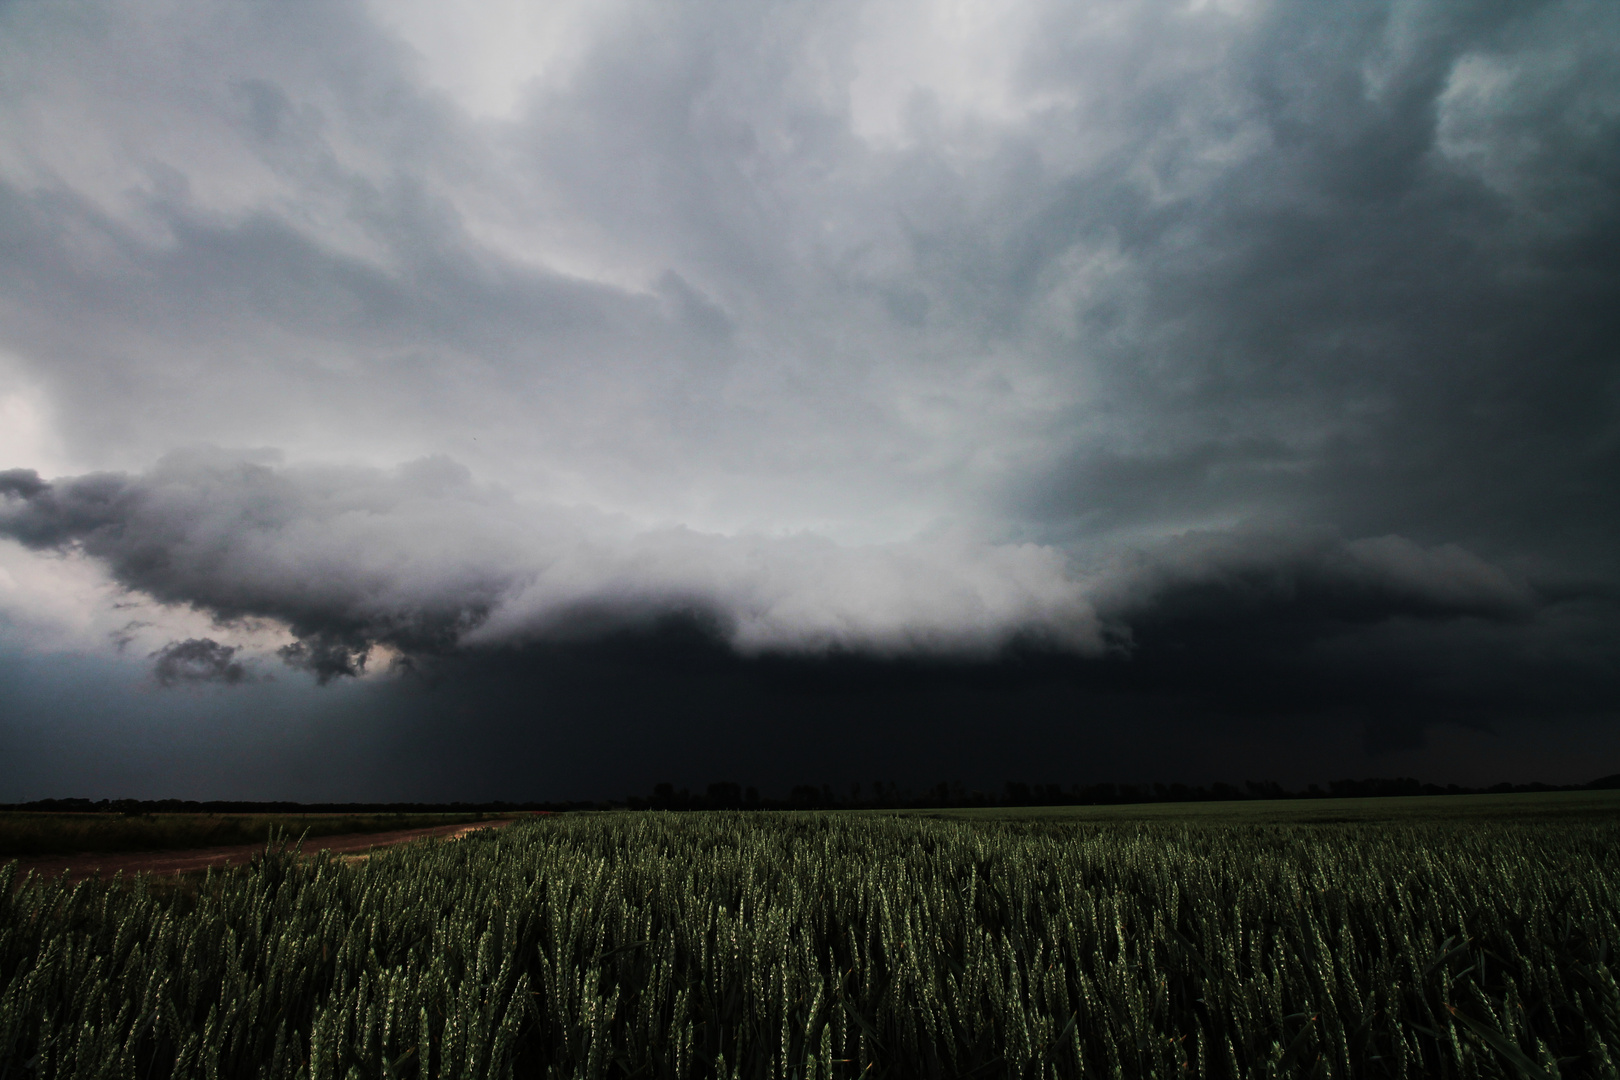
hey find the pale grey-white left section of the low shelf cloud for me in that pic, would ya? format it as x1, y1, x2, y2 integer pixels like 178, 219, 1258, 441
0, 450, 1102, 667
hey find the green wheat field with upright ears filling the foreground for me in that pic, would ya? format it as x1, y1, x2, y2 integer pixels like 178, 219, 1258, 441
0, 793, 1620, 1080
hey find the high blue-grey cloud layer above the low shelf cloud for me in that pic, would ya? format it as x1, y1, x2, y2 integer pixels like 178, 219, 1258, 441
0, 3, 1620, 557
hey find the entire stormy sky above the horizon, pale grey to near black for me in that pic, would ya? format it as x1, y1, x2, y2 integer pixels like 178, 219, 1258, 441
0, 0, 1620, 800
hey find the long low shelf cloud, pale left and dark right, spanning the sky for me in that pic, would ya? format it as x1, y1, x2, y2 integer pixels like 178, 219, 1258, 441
0, 450, 1568, 709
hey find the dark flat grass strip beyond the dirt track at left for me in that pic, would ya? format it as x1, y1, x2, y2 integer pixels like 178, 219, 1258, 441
0, 811, 484, 858
